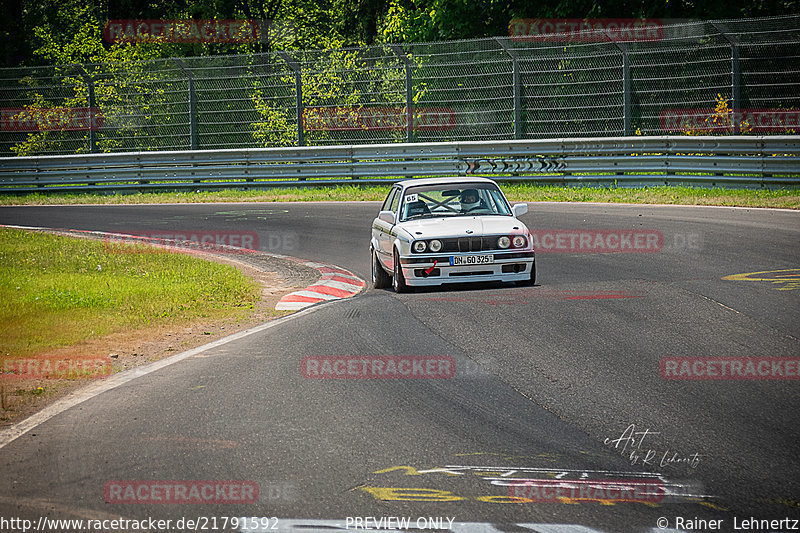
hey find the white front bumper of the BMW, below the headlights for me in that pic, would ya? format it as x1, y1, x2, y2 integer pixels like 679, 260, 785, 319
400, 251, 535, 287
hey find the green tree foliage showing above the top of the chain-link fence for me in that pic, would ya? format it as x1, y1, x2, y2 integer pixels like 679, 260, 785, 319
7, 0, 800, 70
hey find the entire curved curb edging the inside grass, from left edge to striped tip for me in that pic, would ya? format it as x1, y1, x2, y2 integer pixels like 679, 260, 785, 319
0, 224, 366, 311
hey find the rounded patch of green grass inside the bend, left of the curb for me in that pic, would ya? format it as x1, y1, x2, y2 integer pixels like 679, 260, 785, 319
0, 225, 258, 357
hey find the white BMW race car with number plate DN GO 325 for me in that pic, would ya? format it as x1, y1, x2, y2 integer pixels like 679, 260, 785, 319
370, 178, 536, 292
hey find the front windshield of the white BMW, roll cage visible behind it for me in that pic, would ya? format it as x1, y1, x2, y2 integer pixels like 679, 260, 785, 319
400, 183, 511, 221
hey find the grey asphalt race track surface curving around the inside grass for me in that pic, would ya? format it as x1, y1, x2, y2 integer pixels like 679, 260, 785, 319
0, 203, 800, 533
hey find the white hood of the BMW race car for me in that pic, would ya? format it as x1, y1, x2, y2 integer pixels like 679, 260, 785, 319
400, 216, 526, 239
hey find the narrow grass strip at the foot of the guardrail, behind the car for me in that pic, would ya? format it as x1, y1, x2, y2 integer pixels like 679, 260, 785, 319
0, 184, 800, 209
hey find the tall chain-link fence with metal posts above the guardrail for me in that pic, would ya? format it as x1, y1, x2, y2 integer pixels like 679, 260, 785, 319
0, 15, 800, 155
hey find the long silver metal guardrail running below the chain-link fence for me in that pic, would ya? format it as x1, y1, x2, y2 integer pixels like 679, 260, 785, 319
0, 135, 800, 194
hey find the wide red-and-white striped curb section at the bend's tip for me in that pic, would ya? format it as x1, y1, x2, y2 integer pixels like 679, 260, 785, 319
275, 255, 366, 311
